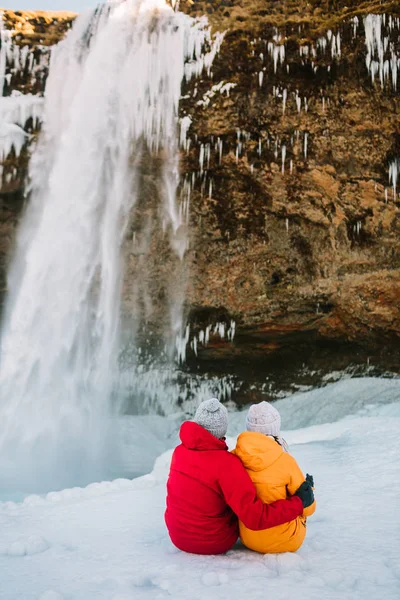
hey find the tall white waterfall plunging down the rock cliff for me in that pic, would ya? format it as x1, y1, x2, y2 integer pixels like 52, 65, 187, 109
0, 0, 221, 489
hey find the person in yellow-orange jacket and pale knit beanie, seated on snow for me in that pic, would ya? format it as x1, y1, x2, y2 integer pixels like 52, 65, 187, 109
233, 402, 316, 554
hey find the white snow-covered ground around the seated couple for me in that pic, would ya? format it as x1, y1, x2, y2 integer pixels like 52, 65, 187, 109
0, 379, 400, 600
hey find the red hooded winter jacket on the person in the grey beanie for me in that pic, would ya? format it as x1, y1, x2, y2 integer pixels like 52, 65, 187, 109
165, 421, 303, 554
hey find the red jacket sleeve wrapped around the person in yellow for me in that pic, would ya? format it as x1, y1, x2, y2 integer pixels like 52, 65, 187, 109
219, 455, 303, 531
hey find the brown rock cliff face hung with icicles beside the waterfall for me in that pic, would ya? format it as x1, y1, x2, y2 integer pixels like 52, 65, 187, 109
0, 0, 400, 380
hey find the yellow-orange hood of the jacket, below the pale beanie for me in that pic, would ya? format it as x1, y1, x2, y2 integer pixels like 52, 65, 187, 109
234, 431, 283, 471
